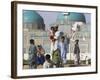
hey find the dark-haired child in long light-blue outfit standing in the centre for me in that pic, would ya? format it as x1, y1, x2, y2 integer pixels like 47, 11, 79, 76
59, 36, 67, 64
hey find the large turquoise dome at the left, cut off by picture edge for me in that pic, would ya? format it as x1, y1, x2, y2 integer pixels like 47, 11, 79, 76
23, 10, 45, 30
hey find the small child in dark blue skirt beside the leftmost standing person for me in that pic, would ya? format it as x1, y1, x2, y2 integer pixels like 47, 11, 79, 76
37, 45, 45, 65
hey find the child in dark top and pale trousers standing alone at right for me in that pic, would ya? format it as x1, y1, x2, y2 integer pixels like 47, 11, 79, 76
74, 40, 80, 65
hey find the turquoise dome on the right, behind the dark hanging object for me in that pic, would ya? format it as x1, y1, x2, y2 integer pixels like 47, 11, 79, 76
57, 12, 86, 23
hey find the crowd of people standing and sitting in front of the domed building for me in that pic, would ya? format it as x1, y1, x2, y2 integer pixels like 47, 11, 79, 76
29, 25, 80, 69
